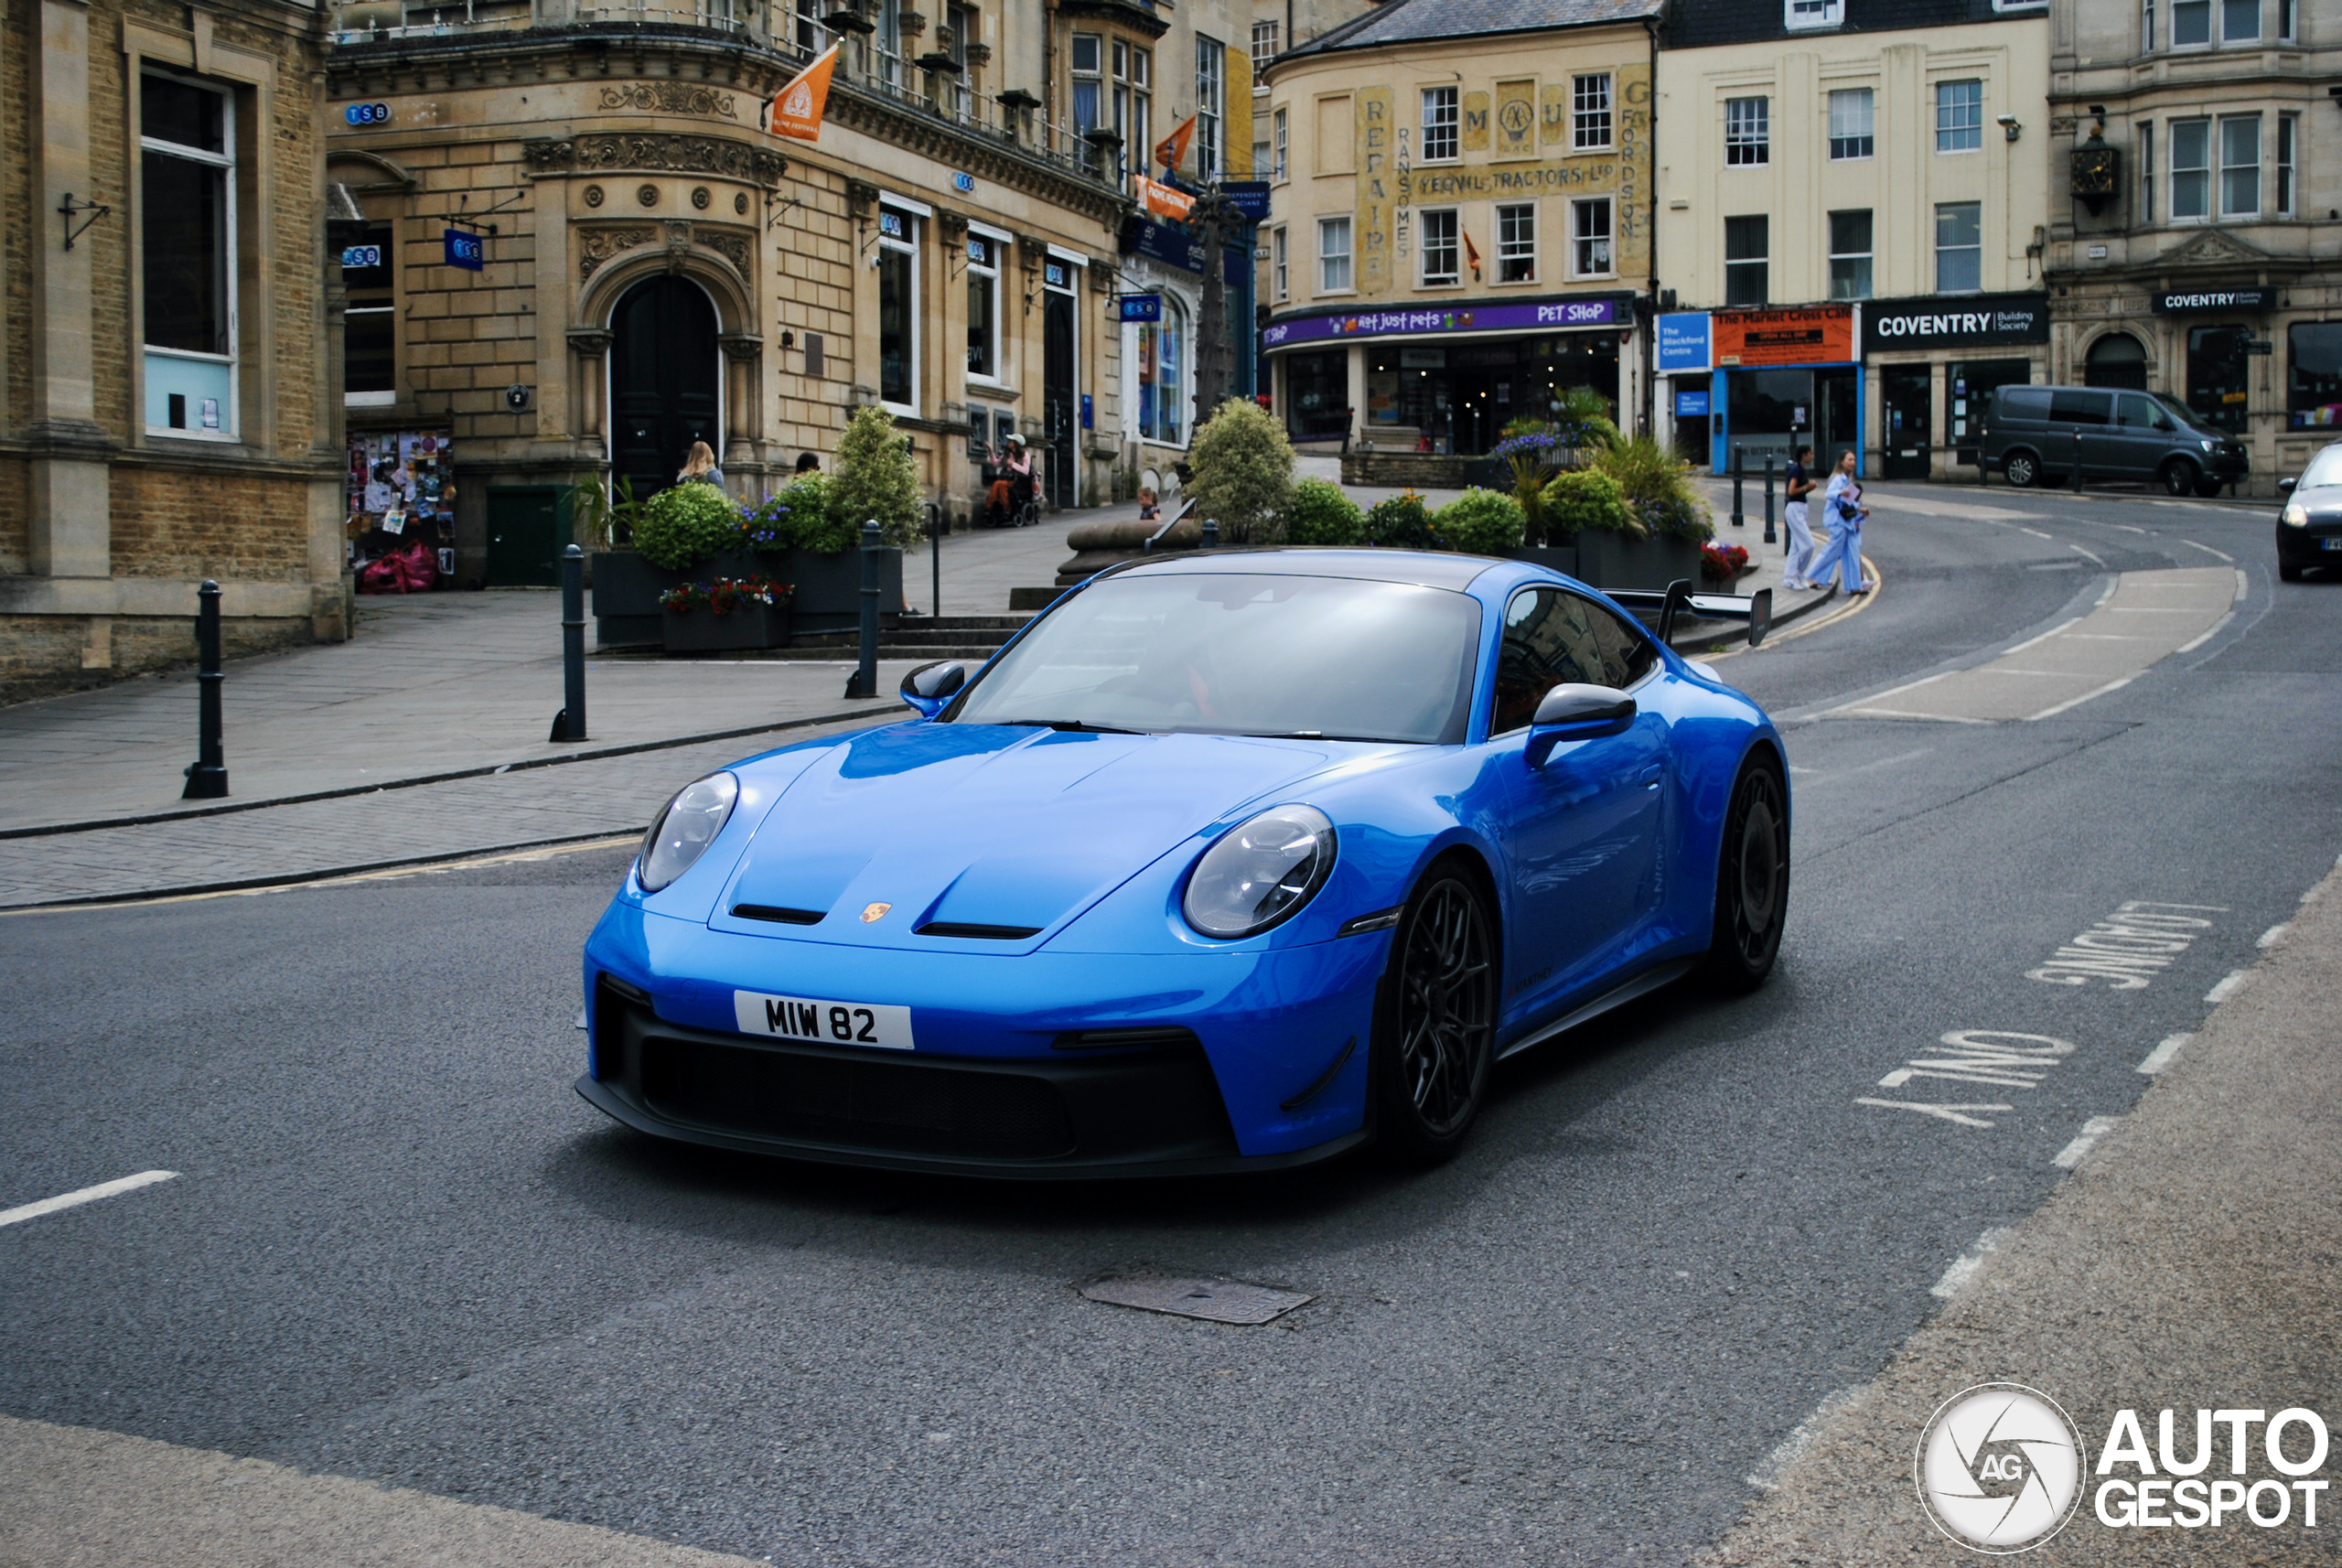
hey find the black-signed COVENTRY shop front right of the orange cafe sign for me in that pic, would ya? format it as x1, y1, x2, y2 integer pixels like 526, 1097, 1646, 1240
1862, 295, 2049, 479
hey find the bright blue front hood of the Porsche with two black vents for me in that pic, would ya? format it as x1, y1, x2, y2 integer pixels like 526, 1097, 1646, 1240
710, 723, 1380, 952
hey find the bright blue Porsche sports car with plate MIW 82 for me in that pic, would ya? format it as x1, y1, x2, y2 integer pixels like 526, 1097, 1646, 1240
578, 550, 1789, 1177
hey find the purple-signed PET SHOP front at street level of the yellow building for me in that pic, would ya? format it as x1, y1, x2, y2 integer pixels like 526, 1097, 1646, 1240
1262, 295, 1635, 456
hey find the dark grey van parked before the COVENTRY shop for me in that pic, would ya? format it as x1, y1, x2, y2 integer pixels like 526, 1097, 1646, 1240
1977, 386, 2253, 496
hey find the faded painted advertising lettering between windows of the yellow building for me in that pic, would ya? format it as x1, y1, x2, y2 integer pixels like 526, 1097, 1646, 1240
1351, 63, 1651, 295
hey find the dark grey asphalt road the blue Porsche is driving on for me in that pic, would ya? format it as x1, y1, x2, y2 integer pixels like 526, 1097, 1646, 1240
0, 487, 2342, 1563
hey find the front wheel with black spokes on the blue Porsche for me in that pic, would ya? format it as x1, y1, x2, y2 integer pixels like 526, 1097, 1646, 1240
1375, 868, 1497, 1165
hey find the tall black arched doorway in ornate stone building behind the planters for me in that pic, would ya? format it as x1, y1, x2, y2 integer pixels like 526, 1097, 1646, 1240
609, 276, 724, 500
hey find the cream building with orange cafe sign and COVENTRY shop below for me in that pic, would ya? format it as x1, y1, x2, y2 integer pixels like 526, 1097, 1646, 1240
1656, 0, 2049, 478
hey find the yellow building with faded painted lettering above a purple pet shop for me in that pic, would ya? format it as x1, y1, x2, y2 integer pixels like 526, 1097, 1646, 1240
1262, 0, 1663, 482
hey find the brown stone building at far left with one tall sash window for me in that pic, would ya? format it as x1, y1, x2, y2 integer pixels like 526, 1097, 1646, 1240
0, 0, 349, 702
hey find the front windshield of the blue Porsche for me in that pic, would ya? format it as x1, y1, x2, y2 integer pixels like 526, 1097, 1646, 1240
949, 571, 1480, 745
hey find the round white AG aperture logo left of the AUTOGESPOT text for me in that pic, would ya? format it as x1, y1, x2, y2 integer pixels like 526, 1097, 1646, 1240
1914, 1383, 2084, 1556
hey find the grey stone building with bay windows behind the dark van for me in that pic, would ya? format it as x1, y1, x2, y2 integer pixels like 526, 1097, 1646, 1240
2049, 0, 2342, 496
